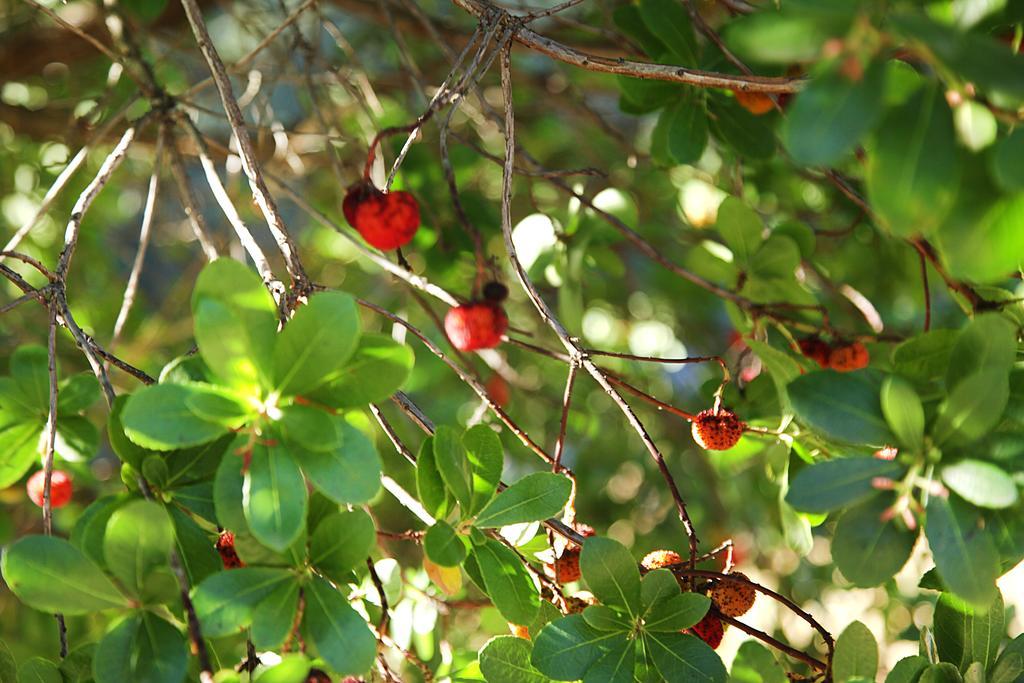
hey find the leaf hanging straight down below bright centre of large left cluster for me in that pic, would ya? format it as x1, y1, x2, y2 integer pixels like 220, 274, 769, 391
242, 443, 308, 552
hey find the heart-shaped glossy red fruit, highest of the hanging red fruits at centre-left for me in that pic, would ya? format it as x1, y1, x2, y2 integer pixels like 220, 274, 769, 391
341, 181, 420, 251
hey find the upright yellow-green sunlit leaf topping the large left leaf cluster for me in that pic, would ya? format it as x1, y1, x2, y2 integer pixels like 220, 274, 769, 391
191, 258, 278, 395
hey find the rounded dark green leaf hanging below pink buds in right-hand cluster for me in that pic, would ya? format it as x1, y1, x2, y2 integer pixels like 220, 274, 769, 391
831, 497, 918, 586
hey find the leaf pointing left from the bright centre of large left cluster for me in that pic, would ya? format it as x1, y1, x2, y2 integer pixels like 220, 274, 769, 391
121, 384, 227, 451
